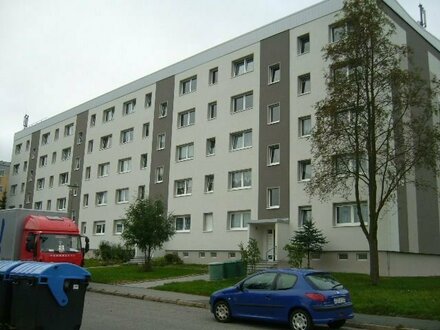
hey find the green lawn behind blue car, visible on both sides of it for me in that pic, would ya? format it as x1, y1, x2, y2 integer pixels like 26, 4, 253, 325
154, 273, 440, 320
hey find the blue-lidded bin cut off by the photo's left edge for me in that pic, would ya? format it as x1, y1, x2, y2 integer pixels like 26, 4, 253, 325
0, 260, 23, 329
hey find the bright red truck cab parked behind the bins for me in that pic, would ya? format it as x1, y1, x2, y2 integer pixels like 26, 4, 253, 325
20, 215, 88, 266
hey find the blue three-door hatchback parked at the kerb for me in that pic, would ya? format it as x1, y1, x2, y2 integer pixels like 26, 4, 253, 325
209, 269, 353, 330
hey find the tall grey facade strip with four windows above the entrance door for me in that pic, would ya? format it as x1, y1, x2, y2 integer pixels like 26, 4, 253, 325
258, 31, 290, 219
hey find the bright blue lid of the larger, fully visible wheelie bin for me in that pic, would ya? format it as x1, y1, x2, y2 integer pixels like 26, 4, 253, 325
9, 262, 90, 306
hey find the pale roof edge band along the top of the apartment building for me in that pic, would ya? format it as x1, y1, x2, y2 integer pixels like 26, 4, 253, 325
14, 0, 440, 139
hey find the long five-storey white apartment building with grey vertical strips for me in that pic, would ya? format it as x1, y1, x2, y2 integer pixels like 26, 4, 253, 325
8, 0, 440, 275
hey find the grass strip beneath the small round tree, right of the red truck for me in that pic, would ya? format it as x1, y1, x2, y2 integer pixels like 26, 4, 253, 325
87, 264, 208, 284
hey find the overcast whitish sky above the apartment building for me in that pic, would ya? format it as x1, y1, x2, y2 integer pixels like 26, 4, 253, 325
0, 0, 440, 161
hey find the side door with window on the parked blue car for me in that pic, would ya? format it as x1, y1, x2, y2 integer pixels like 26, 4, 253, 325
232, 272, 277, 318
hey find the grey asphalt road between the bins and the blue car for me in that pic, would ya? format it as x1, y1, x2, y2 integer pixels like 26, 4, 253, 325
81, 292, 359, 330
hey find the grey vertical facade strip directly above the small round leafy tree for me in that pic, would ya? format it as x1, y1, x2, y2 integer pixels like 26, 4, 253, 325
149, 76, 174, 203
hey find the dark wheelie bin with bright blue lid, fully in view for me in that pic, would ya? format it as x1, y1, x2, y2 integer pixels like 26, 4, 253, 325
9, 262, 90, 330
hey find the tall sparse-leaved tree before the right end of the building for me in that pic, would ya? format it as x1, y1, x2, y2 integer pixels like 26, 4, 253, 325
307, 0, 440, 284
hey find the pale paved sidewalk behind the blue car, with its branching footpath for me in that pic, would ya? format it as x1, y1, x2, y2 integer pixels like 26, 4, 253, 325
88, 274, 440, 330
